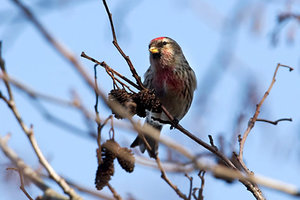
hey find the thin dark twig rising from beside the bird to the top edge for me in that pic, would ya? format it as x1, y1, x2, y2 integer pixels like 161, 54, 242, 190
102, 0, 145, 89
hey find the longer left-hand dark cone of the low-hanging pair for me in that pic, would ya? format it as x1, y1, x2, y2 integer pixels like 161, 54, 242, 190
95, 140, 120, 190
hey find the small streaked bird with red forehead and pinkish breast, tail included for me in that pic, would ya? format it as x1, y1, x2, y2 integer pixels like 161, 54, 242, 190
130, 37, 197, 158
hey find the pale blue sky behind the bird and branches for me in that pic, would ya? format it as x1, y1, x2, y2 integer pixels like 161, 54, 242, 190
0, 0, 300, 200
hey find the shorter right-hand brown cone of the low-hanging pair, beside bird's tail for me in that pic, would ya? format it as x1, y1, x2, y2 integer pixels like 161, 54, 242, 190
117, 148, 135, 173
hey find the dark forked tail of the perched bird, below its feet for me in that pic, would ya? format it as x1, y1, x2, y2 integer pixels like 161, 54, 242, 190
130, 118, 162, 158
